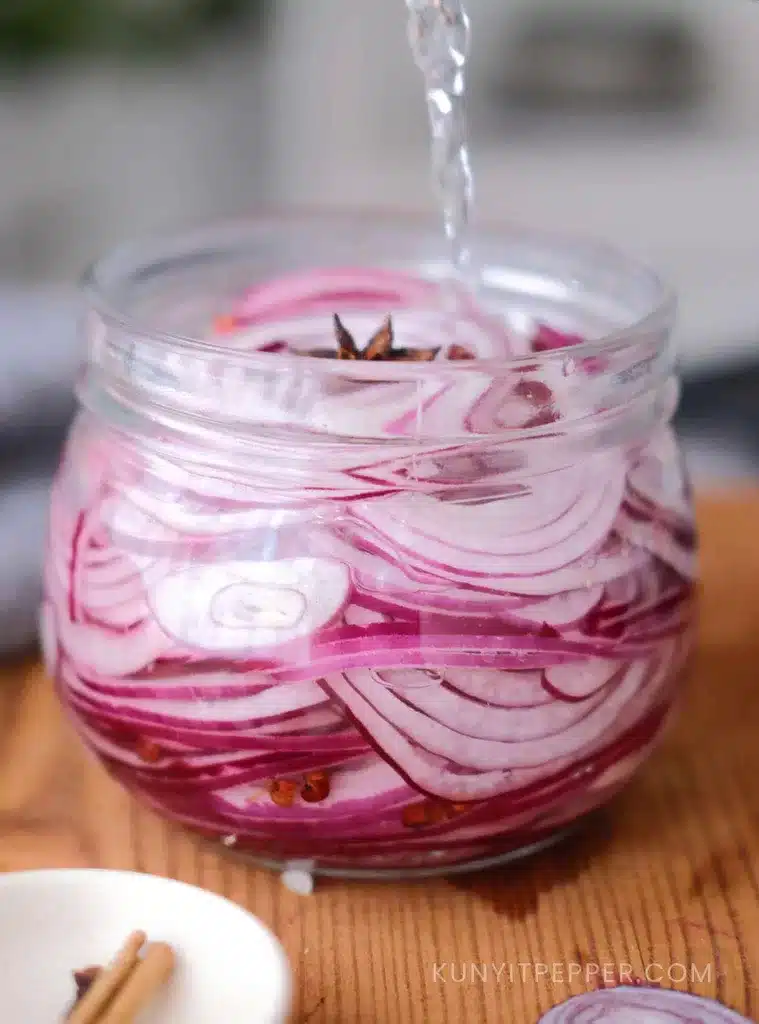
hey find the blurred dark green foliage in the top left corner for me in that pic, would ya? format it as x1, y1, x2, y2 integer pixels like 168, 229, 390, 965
0, 0, 270, 69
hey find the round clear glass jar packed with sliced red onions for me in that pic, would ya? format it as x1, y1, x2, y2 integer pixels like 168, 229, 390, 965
42, 215, 695, 876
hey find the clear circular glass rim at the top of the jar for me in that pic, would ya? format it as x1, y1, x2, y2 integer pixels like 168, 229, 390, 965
82, 209, 677, 380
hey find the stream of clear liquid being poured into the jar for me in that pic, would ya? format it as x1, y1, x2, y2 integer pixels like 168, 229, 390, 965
407, 0, 473, 279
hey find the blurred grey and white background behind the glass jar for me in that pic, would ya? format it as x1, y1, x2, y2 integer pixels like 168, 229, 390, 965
0, 0, 759, 650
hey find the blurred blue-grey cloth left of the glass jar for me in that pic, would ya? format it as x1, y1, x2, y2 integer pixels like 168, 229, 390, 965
0, 288, 83, 654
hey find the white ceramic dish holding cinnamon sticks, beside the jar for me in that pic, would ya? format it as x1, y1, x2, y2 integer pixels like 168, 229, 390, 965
0, 870, 291, 1024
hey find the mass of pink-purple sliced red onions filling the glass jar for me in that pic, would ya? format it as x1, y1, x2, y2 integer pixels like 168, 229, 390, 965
41, 268, 694, 872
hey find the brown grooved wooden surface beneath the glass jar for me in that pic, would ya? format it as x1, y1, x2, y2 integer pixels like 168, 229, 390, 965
0, 492, 759, 1024
